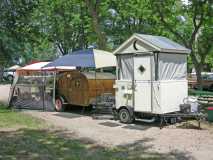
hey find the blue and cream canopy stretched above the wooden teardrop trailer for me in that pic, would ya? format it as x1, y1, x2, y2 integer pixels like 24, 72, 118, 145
43, 49, 116, 69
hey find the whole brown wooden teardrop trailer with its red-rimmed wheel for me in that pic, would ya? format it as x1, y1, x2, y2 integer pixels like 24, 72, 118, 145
55, 70, 116, 111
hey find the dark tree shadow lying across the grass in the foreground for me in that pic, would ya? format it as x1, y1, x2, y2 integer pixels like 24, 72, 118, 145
0, 129, 195, 160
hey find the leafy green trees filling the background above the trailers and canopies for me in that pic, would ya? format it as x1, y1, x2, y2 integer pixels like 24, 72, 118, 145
0, 0, 213, 84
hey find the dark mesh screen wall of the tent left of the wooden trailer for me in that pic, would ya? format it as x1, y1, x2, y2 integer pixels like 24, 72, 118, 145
10, 74, 54, 111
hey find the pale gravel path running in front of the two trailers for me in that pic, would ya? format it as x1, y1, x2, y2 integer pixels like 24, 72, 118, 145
26, 111, 213, 160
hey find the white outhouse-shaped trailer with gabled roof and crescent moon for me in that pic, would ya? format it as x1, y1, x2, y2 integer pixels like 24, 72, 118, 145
114, 34, 190, 123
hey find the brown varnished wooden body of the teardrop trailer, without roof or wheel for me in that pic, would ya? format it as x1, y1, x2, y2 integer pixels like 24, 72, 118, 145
57, 71, 115, 106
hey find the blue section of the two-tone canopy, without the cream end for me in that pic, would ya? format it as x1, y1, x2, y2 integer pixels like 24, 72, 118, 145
43, 49, 96, 68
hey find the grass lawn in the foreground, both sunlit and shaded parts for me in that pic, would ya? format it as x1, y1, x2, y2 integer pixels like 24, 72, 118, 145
0, 106, 183, 160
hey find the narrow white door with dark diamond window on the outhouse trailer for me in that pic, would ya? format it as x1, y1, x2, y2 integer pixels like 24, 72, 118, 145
134, 56, 152, 112
